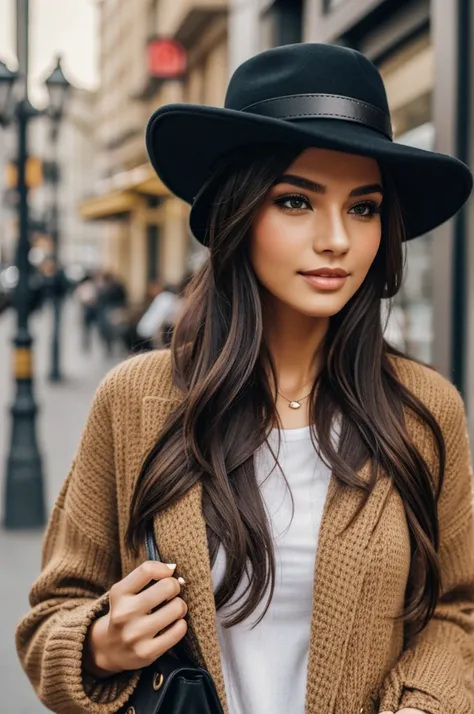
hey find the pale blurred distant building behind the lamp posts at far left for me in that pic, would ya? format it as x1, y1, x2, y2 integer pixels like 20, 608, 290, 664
0, 83, 100, 268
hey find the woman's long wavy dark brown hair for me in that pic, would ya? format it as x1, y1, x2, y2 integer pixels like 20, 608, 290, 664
127, 146, 445, 631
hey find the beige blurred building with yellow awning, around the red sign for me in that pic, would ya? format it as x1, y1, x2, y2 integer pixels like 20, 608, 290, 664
80, 0, 228, 304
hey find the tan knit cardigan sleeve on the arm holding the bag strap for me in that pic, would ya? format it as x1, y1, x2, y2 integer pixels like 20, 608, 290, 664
16, 377, 139, 714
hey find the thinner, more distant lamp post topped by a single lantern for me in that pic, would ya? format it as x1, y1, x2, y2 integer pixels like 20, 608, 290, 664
45, 57, 71, 382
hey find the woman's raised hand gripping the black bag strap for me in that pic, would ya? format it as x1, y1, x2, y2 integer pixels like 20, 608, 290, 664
84, 560, 188, 678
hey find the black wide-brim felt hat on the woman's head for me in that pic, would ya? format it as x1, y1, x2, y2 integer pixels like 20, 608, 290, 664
146, 43, 472, 245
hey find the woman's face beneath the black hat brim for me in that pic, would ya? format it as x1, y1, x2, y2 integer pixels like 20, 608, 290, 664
250, 148, 382, 317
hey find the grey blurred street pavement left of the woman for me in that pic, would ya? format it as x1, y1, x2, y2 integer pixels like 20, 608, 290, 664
0, 300, 122, 714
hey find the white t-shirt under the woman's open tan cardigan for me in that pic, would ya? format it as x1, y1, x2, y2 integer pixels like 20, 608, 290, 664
212, 427, 331, 714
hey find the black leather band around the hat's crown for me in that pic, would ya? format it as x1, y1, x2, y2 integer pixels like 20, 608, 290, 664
241, 94, 393, 141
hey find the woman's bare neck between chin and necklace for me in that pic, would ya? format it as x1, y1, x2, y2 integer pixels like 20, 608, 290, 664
264, 296, 329, 399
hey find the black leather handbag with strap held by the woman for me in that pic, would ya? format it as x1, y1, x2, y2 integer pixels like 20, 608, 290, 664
120, 525, 224, 714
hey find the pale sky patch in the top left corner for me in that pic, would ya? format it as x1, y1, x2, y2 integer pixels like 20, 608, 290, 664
0, 0, 98, 104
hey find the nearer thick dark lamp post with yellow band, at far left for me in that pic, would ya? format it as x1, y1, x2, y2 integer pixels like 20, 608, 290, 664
0, 0, 70, 529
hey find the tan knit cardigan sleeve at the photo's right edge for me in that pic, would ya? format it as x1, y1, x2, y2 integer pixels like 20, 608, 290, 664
380, 387, 474, 714
